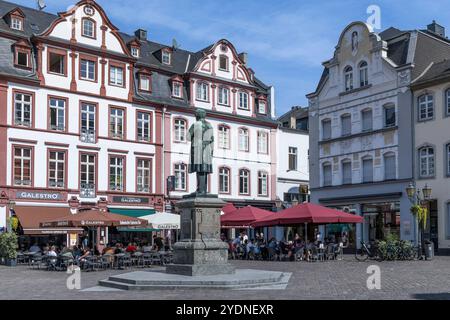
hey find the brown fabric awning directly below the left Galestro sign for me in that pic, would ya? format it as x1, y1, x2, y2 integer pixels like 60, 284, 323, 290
14, 206, 83, 235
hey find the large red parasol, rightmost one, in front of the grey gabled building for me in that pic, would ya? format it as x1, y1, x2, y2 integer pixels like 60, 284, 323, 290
252, 203, 363, 227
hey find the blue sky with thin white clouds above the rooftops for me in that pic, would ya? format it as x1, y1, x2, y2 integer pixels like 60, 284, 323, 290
9, 0, 450, 115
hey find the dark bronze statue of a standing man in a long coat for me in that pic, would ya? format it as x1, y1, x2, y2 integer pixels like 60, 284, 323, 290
188, 109, 214, 195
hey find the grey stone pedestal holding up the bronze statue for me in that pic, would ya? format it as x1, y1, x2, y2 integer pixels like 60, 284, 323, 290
166, 196, 235, 276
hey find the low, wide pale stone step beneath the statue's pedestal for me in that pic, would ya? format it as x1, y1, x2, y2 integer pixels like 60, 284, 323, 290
99, 269, 291, 290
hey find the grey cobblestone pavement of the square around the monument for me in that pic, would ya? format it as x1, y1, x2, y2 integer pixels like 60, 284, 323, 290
0, 256, 450, 300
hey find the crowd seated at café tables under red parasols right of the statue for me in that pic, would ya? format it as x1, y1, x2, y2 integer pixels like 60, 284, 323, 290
227, 232, 344, 261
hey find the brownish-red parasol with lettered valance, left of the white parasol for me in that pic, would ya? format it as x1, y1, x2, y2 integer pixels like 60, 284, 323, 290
40, 210, 148, 228
